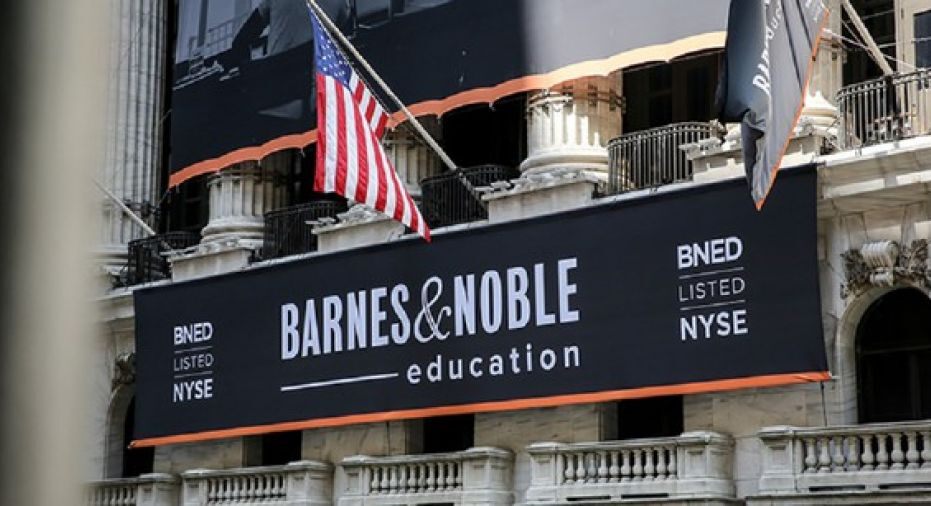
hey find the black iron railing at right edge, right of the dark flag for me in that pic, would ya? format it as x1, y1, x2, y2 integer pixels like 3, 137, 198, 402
837, 69, 931, 149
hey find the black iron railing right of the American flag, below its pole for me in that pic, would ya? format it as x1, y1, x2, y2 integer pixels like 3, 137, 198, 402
420, 165, 520, 227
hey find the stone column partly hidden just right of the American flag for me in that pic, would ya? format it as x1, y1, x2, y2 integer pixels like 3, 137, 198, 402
382, 121, 443, 201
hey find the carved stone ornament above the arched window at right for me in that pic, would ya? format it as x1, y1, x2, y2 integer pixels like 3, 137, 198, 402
841, 239, 931, 297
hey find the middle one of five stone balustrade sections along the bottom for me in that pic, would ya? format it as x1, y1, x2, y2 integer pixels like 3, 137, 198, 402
339, 448, 513, 506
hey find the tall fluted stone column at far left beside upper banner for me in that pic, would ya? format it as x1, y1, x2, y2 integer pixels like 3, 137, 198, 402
97, 0, 167, 273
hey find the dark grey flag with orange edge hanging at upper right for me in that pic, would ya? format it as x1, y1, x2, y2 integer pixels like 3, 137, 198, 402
718, 0, 828, 209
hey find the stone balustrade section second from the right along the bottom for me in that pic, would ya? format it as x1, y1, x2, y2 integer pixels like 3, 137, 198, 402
527, 432, 735, 504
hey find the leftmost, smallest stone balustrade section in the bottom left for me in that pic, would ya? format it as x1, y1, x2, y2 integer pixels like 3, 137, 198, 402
84, 474, 178, 506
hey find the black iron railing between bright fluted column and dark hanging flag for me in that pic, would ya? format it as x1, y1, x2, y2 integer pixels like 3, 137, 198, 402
608, 122, 719, 194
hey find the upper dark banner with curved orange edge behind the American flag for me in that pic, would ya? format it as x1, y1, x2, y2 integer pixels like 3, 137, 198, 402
171, 0, 727, 185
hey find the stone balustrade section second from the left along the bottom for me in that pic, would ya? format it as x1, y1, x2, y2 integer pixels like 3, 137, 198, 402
181, 461, 333, 506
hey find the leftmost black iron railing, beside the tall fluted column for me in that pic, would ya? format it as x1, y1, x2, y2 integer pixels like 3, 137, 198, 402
125, 232, 200, 285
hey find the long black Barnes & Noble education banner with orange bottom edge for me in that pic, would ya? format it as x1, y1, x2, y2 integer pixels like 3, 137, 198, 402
135, 167, 826, 444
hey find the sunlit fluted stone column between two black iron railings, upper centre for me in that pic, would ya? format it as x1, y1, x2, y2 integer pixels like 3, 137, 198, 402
520, 74, 621, 179
